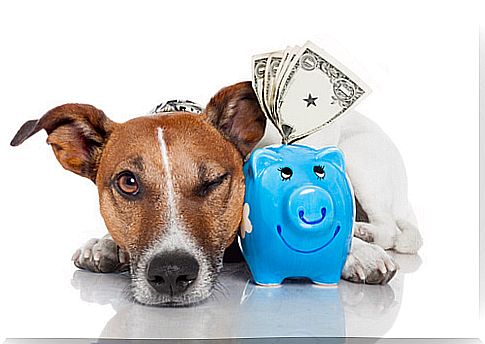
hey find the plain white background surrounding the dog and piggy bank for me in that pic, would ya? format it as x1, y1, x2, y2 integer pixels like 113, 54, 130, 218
0, 1, 483, 337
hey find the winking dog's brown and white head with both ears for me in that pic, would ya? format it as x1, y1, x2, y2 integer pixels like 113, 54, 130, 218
12, 82, 266, 305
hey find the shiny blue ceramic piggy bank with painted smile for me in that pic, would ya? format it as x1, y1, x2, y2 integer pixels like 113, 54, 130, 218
240, 145, 355, 285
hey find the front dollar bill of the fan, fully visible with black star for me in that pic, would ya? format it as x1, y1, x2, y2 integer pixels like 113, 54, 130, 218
275, 42, 370, 143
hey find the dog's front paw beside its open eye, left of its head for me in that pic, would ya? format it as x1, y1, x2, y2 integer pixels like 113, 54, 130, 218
72, 236, 130, 272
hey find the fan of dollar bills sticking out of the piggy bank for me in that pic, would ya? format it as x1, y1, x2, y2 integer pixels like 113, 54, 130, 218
252, 42, 370, 143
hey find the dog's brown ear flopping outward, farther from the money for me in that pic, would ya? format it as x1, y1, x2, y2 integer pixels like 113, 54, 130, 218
10, 104, 116, 182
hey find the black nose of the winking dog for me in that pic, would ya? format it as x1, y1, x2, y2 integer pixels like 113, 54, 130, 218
146, 252, 199, 296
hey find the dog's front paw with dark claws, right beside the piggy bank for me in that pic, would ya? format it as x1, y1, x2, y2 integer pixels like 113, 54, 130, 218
342, 238, 397, 284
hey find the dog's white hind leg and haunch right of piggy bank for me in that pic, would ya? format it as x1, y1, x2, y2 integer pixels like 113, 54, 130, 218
339, 113, 422, 253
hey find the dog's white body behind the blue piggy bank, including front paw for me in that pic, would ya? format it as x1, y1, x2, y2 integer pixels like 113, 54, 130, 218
258, 111, 422, 280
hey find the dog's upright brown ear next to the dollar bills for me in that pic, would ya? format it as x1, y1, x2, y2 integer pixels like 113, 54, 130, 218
205, 81, 266, 157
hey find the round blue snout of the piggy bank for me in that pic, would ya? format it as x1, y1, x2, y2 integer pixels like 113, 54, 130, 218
286, 185, 334, 230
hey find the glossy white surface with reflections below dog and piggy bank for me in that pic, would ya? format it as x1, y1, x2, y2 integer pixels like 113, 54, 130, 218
65, 255, 421, 338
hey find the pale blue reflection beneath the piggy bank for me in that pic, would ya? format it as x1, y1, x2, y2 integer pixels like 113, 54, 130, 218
237, 282, 344, 338
